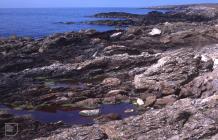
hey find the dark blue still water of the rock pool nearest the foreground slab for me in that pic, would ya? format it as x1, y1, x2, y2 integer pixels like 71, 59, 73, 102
0, 103, 137, 125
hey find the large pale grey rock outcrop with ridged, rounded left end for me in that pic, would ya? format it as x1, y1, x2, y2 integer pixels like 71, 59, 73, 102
134, 49, 213, 95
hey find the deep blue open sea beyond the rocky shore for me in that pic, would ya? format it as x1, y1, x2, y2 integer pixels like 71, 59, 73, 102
0, 8, 158, 38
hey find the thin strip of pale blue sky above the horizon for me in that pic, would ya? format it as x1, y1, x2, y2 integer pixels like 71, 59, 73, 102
0, 0, 218, 8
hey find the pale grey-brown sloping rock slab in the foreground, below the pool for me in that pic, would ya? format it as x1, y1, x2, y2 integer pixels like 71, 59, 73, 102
36, 95, 218, 140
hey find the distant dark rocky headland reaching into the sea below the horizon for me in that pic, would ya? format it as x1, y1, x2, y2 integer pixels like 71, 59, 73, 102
54, 7, 217, 27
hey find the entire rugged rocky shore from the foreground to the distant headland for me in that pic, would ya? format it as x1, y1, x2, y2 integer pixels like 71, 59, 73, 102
0, 3, 218, 140
